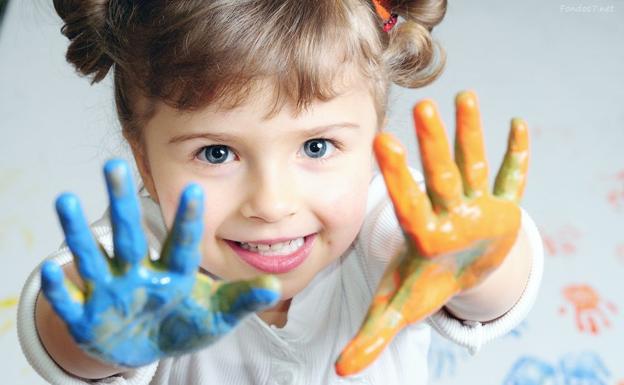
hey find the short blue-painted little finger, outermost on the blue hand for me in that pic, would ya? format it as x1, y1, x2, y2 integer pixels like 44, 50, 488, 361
41, 261, 83, 325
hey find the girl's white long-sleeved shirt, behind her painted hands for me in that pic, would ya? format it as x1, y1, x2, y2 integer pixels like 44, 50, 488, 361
17, 170, 543, 385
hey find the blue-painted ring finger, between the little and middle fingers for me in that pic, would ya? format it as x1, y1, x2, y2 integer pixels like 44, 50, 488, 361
56, 193, 110, 282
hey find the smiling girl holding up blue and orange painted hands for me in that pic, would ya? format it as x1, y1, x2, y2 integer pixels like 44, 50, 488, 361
14, 0, 542, 384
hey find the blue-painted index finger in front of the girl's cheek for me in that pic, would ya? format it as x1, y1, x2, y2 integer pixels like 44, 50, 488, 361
158, 184, 204, 274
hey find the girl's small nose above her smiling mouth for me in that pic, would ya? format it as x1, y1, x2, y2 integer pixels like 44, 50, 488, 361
241, 167, 299, 223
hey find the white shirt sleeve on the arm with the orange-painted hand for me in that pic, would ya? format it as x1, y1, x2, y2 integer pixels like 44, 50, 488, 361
358, 167, 544, 354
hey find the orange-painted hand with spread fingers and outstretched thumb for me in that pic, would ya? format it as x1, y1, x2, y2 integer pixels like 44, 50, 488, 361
336, 92, 529, 376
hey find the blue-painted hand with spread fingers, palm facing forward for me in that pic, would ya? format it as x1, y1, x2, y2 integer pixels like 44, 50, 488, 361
41, 160, 280, 367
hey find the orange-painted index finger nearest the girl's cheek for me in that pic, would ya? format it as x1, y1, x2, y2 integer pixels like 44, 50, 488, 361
373, 133, 435, 242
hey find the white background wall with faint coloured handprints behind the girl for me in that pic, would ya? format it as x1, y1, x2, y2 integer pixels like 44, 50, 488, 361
0, 0, 624, 385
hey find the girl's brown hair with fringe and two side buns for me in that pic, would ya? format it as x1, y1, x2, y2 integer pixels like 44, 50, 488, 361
54, 0, 446, 144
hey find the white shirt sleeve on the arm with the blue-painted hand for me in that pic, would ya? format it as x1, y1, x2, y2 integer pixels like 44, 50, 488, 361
17, 221, 158, 385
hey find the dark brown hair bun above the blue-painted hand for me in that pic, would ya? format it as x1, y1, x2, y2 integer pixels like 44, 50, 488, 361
54, 0, 114, 83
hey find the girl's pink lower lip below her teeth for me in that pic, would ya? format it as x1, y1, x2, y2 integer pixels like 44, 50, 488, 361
225, 234, 316, 274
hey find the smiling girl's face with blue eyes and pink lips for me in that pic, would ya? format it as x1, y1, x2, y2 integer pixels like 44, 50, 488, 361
135, 76, 377, 299
